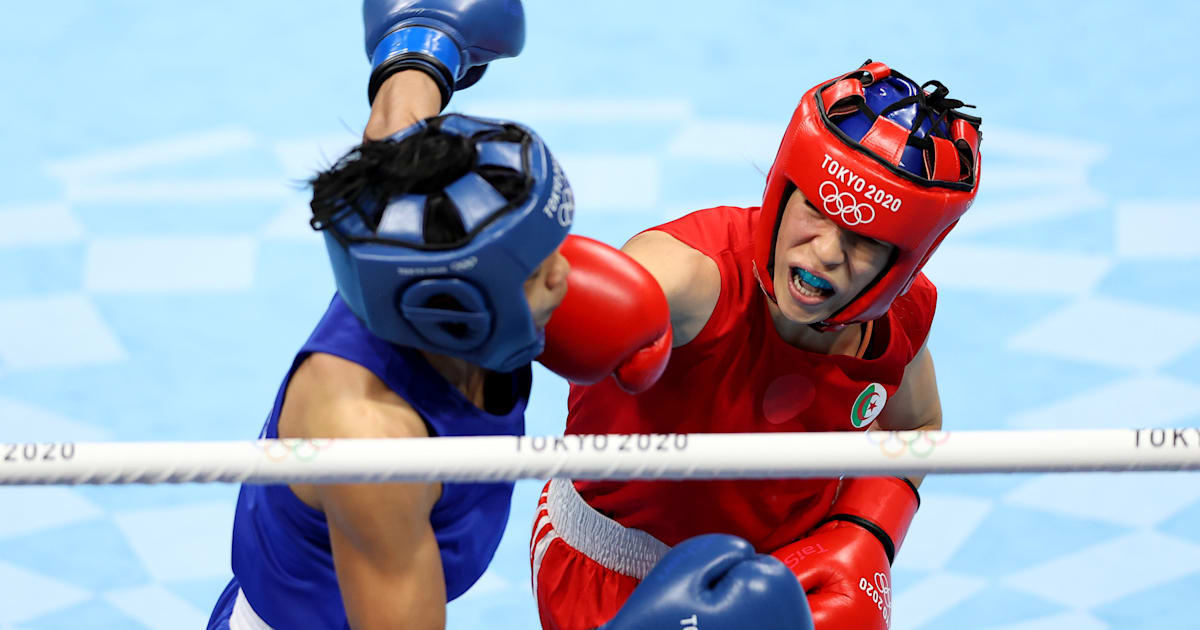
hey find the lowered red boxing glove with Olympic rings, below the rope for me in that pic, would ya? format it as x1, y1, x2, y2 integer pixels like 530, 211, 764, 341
772, 476, 920, 630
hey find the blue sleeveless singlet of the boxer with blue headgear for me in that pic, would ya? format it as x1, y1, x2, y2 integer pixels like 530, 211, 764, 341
209, 295, 532, 630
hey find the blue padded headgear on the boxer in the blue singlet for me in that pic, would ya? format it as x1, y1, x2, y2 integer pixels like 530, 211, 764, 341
313, 114, 575, 372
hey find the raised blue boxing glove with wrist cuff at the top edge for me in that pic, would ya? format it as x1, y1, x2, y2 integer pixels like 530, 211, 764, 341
362, 0, 524, 108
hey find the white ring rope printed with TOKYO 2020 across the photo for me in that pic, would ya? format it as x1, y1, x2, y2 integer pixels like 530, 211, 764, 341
0, 428, 1200, 485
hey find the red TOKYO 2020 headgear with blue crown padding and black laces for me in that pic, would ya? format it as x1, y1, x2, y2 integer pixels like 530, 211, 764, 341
754, 61, 980, 330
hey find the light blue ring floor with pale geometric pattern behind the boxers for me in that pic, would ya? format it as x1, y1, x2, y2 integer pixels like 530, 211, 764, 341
0, 0, 1200, 630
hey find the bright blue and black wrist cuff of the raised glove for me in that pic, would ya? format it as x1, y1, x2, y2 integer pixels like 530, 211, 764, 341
367, 25, 463, 108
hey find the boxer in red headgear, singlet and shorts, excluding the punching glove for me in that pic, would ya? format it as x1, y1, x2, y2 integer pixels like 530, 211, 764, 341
530, 62, 979, 630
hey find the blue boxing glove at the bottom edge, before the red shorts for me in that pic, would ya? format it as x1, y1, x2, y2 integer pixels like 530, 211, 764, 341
598, 534, 812, 630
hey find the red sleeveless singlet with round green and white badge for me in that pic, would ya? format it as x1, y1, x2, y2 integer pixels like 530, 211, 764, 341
566, 206, 937, 552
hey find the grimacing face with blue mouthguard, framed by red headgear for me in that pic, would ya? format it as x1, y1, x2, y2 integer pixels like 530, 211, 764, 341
773, 188, 893, 324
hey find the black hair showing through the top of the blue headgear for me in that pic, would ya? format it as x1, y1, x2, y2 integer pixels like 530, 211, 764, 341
308, 116, 528, 246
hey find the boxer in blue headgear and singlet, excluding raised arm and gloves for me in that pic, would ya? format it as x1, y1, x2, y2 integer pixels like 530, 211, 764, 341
209, 116, 574, 629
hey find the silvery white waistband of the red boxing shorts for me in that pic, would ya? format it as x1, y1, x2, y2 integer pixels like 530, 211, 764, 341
546, 479, 671, 580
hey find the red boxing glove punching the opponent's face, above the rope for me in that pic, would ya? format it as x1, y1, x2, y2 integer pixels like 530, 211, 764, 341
538, 234, 671, 394
